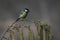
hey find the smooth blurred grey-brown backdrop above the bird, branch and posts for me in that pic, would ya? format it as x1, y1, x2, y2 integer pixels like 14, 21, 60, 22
0, 0, 60, 40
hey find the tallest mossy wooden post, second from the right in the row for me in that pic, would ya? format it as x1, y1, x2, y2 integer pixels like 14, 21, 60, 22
35, 21, 43, 40
